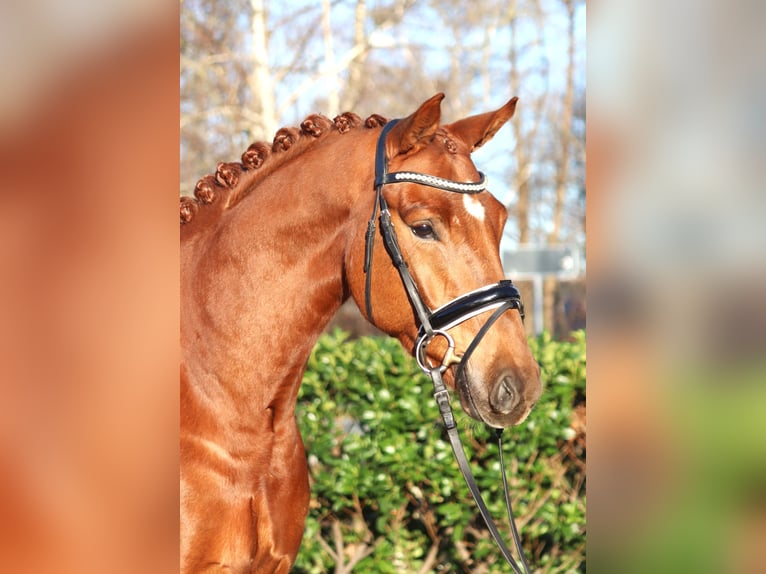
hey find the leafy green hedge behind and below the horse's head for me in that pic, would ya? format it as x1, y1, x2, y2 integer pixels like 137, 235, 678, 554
294, 331, 585, 574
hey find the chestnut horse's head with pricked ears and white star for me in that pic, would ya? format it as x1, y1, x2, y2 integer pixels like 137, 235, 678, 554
346, 94, 541, 428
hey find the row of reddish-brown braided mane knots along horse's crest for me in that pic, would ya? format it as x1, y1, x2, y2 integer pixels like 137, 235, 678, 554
180, 112, 388, 225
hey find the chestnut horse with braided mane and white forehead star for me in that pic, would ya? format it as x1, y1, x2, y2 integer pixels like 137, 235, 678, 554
180, 94, 541, 573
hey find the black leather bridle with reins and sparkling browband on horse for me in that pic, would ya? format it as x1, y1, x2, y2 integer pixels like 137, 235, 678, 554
364, 120, 530, 574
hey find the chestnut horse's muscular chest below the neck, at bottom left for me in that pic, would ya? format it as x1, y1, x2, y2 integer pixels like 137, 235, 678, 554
181, 418, 309, 572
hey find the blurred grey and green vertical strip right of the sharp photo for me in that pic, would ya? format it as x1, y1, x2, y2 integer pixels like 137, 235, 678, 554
588, 2, 766, 573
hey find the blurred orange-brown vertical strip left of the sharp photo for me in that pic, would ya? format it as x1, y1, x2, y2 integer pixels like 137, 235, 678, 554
0, 2, 178, 573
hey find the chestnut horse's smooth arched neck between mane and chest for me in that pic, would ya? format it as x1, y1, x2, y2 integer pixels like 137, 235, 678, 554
181, 130, 374, 408
